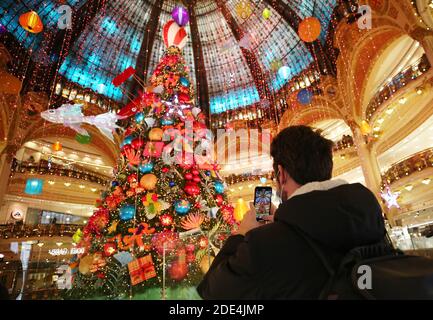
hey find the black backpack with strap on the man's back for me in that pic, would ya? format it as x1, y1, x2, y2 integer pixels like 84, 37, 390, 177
293, 227, 433, 300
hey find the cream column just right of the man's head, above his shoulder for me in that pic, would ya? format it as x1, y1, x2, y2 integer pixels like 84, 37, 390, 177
352, 126, 382, 199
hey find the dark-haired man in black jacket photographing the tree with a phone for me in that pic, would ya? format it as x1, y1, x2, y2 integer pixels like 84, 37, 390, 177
197, 126, 386, 300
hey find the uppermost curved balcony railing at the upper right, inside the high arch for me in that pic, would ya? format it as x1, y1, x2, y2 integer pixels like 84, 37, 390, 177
365, 55, 431, 122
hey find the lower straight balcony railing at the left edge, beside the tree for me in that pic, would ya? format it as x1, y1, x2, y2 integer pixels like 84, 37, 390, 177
0, 224, 83, 239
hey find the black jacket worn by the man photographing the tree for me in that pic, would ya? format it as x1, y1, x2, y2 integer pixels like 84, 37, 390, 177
197, 184, 386, 299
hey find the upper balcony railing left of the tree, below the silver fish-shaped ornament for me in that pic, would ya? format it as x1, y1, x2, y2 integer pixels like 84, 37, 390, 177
11, 160, 111, 186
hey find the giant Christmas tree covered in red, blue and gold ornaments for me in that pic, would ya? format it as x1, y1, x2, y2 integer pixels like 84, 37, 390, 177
66, 21, 235, 299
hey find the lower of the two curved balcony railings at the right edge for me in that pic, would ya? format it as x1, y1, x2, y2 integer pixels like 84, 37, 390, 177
382, 148, 433, 186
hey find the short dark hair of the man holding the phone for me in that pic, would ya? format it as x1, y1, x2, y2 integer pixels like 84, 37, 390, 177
271, 126, 334, 185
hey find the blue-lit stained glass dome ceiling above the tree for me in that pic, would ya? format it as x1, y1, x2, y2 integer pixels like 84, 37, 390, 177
0, 0, 337, 113
